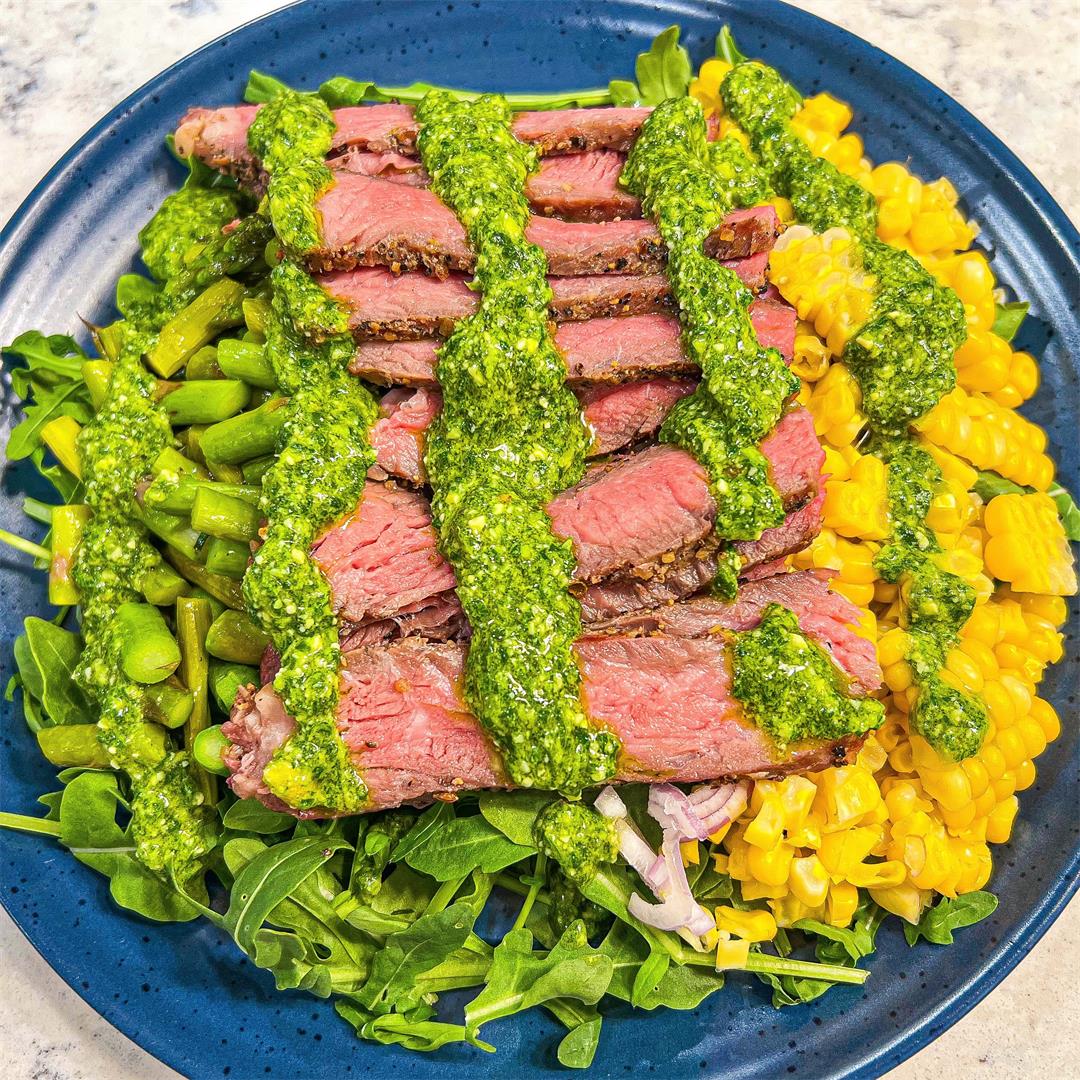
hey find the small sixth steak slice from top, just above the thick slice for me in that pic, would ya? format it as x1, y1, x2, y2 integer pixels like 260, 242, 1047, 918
368, 379, 694, 484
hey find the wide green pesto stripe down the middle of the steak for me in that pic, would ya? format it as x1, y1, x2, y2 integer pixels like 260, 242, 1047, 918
417, 91, 619, 793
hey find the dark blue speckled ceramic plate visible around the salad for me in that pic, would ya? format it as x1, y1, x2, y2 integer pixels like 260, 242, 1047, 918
0, 0, 1080, 1080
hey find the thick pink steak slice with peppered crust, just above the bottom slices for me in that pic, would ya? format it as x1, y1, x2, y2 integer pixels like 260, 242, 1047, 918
314, 408, 824, 639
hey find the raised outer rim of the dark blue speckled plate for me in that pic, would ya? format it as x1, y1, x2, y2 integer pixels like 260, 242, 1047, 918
0, 0, 1080, 1078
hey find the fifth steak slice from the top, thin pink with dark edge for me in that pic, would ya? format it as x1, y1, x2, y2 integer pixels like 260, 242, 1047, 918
349, 299, 795, 387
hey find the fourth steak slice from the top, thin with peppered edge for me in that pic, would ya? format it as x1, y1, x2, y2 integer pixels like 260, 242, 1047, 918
315, 252, 774, 341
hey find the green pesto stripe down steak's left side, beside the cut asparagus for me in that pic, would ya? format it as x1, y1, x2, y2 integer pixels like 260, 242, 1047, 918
243, 94, 378, 812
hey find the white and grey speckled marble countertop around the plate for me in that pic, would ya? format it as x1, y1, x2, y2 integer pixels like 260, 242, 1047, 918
0, 0, 1080, 1080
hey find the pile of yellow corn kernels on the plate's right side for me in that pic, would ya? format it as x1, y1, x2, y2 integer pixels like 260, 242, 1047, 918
690, 59, 1077, 946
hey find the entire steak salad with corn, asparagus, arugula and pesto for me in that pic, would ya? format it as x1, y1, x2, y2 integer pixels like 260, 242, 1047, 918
0, 21, 1080, 1068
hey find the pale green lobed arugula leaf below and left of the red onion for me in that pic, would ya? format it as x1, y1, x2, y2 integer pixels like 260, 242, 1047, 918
465, 922, 613, 1041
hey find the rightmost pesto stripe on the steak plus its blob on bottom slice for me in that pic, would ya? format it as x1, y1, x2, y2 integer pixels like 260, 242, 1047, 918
622, 97, 885, 746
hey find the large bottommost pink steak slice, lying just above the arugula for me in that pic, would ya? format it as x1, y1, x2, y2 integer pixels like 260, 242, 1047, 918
225, 571, 880, 809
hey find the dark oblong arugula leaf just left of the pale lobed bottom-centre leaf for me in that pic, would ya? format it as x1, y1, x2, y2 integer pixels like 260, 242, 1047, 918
354, 903, 477, 1013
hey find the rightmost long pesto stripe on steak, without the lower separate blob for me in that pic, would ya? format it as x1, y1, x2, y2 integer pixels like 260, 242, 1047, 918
622, 97, 799, 595
